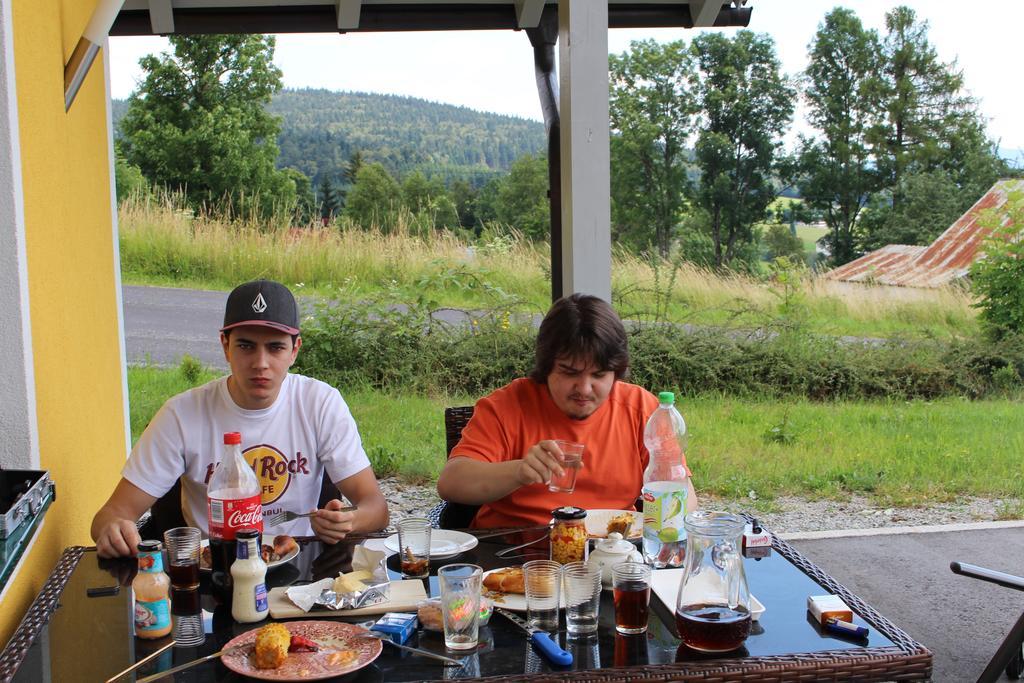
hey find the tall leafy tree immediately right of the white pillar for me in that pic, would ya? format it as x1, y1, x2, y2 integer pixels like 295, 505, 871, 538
608, 40, 695, 257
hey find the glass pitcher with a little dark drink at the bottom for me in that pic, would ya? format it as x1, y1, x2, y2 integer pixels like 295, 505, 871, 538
676, 510, 751, 652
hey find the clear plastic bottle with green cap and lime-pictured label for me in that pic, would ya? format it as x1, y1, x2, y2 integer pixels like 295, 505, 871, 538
642, 391, 689, 568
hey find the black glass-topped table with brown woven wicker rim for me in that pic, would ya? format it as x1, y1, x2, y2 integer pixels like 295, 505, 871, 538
0, 529, 932, 683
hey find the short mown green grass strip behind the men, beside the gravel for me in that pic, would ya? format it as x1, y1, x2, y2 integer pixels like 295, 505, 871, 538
128, 368, 1024, 505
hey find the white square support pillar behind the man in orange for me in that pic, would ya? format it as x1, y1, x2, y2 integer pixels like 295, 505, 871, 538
558, 0, 611, 301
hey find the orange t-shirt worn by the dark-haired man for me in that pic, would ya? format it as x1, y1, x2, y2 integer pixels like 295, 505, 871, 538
452, 379, 657, 528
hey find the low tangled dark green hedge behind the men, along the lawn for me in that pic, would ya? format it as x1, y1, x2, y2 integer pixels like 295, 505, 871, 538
296, 292, 1024, 400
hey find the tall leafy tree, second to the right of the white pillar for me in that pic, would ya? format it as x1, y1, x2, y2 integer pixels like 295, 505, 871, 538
691, 31, 796, 267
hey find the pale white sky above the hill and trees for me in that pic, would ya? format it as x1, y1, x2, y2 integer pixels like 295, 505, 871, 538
110, 0, 1024, 157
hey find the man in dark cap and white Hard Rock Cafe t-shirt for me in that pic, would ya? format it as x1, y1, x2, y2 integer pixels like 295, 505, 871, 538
91, 280, 388, 557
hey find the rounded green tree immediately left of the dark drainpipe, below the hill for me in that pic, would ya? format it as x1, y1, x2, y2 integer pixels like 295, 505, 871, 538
495, 155, 551, 240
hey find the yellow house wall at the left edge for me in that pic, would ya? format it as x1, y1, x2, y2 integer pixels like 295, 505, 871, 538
0, 0, 126, 642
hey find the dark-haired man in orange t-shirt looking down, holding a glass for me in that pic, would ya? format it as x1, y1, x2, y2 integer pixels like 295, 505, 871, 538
437, 294, 696, 527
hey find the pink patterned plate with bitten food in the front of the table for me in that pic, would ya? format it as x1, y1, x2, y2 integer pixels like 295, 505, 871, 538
221, 622, 383, 681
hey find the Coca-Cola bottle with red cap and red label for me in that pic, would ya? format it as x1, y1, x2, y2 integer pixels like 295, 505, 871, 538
207, 432, 263, 604
